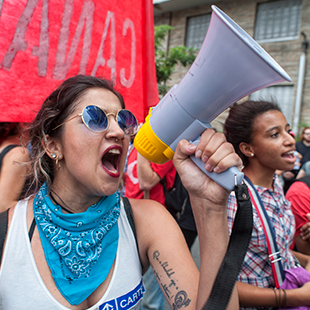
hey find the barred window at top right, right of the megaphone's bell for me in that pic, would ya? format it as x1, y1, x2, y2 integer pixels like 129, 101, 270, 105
254, 0, 301, 42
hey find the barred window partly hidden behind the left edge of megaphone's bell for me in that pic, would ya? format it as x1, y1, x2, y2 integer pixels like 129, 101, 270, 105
186, 13, 211, 49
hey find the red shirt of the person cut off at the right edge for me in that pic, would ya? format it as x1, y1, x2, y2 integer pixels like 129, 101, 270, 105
285, 182, 310, 236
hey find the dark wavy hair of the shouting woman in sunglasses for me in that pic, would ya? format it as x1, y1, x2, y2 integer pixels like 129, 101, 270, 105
29, 75, 125, 190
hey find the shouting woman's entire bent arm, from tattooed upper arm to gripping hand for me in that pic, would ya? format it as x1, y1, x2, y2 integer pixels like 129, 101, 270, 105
134, 129, 242, 309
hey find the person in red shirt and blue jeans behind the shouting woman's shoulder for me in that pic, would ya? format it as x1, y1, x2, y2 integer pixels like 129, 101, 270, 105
124, 145, 176, 310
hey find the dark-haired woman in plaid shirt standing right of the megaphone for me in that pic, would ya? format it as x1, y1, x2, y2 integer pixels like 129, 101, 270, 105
224, 101, 310, 309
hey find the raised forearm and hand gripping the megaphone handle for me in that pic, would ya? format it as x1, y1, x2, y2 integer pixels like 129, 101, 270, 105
174, 129, 242, 309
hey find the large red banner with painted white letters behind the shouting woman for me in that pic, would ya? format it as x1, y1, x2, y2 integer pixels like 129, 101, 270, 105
0, 0, 158, 122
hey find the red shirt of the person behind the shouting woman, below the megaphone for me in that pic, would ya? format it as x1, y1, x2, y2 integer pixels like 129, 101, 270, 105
124, 149, 176, 205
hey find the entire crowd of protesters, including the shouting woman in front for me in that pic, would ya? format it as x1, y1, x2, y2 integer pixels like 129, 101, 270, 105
0, 75, 310, 310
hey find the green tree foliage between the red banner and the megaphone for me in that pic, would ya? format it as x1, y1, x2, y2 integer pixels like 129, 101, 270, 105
155, 25, 197, 96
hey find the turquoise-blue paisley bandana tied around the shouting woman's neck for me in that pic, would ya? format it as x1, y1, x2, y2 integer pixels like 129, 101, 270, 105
33, 184, 120, 305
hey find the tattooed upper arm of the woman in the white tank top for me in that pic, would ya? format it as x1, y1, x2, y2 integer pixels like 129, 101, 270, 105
131, 200, 199, 309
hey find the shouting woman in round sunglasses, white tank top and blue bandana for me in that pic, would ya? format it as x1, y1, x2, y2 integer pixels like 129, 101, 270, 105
0, 75, 242, 310
